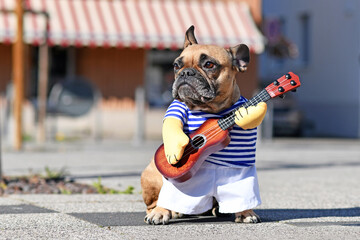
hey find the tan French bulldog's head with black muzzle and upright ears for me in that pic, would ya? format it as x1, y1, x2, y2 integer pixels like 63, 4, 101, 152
172, 26, 250, 113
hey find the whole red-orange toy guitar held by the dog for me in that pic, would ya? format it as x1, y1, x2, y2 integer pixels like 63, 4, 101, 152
154, 72, 301, 182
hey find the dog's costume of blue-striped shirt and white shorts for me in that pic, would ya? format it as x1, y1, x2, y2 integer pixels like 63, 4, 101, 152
157, 97, 266, 214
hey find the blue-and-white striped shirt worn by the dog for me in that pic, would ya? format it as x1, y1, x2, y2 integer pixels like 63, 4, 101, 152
164, 97, 257, 168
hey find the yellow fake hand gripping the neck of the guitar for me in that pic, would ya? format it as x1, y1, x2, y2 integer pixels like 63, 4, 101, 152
235, 102, 267, 129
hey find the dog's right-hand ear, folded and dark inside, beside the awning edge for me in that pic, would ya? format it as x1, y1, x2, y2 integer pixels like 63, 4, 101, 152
228, 44, 250, 72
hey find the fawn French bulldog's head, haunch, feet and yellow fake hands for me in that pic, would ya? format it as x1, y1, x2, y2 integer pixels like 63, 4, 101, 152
141, 26, 266, 225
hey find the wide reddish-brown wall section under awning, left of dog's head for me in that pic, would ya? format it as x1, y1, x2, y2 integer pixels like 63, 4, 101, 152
76, 48, 145, 98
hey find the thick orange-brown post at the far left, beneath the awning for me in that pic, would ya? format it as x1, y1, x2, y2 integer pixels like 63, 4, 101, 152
12, 0, 25, 150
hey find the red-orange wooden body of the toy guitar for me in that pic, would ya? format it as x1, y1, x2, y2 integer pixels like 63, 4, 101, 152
154, 119, 230, 182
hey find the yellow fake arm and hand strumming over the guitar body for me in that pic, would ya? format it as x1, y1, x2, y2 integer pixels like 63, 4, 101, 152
162, 118, 189, 164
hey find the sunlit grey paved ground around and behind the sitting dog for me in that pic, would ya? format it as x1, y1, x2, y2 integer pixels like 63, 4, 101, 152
0, 139, 360, 239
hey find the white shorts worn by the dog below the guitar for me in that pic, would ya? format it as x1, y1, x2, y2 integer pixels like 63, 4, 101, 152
157, 162, 261, 214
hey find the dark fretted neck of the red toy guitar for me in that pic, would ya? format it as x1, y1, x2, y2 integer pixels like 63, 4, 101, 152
218, 89, 271, 130
